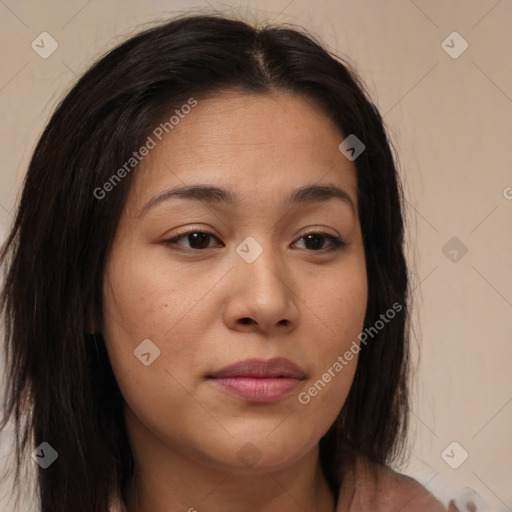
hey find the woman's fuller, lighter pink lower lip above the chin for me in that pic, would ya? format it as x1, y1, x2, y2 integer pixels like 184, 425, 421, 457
213, 377, 300, 403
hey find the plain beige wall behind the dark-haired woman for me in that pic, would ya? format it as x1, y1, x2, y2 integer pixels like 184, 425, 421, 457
0, 0, 512, 512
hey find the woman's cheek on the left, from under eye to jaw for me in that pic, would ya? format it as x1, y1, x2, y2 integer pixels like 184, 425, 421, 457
103, 251, 211, 436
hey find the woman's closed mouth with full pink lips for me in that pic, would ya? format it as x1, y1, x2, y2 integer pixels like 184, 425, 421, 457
207, 357, 306, 403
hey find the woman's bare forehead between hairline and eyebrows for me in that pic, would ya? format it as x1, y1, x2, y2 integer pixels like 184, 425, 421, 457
126, 91, 357, 212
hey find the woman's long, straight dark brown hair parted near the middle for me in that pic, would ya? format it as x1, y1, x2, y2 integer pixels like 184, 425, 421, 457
0, 15, 409, 512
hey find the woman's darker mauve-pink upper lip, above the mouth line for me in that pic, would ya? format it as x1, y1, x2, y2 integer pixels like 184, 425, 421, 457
209, 357, 305, 379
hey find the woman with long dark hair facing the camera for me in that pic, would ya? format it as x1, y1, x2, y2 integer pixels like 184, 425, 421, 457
1, 11, 444, 512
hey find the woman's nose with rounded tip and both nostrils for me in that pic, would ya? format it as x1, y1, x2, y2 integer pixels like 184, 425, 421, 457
224, 241, 299, 336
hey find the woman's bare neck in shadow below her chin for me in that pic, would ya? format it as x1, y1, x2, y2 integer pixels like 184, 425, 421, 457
124, 420, 335, 512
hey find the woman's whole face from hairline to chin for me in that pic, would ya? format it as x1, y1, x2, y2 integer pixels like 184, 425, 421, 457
102, 92, 367, 472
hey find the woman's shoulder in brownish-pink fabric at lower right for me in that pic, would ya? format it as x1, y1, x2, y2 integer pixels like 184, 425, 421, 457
337, 459, 447, 512
